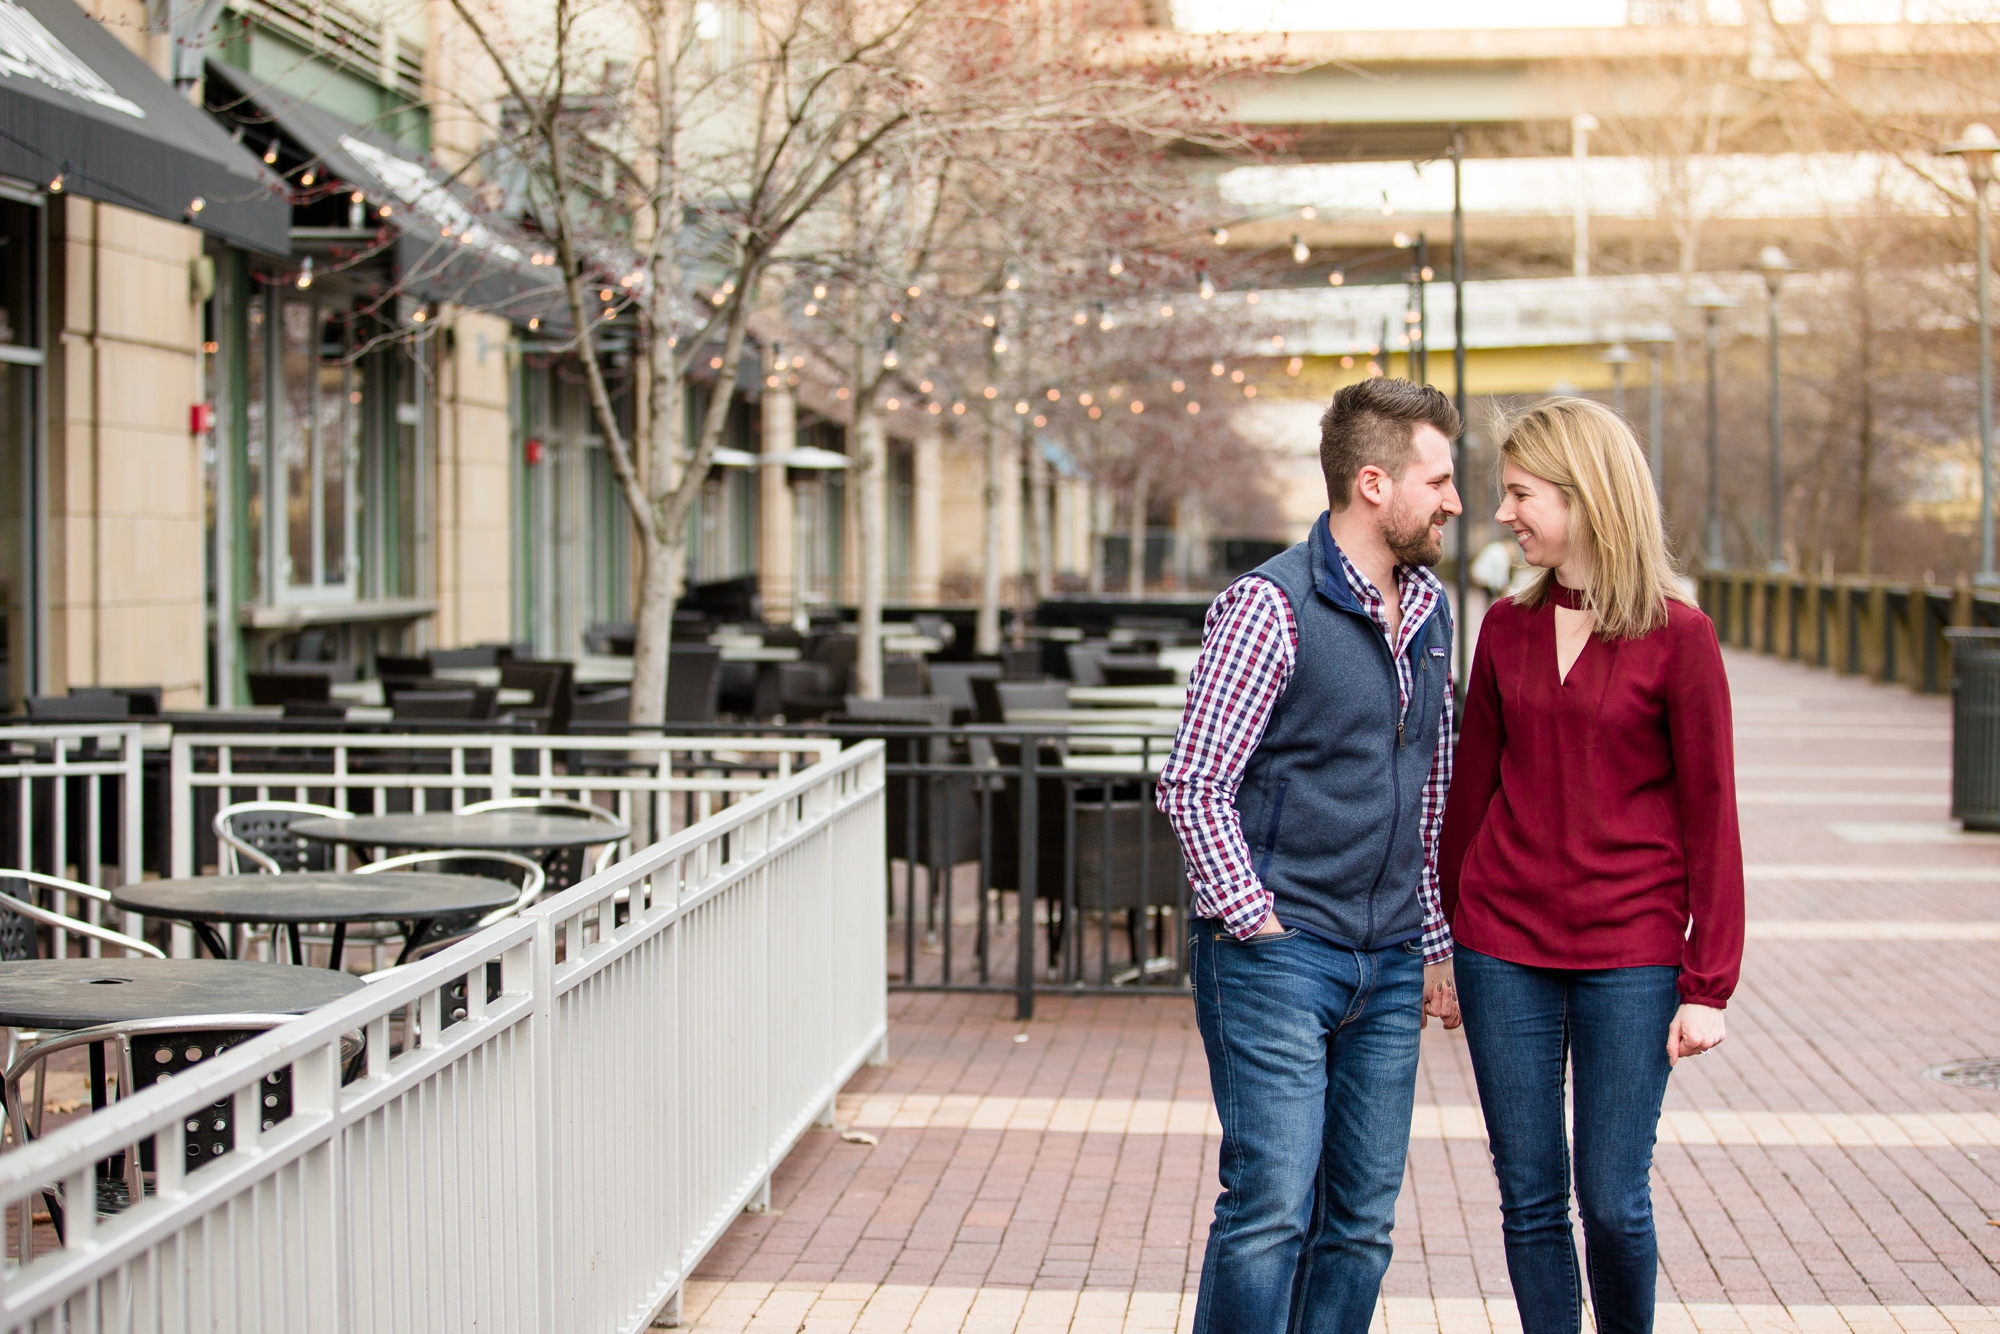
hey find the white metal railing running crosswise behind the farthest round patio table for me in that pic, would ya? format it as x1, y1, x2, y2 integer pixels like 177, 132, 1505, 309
168, 732, 840, 876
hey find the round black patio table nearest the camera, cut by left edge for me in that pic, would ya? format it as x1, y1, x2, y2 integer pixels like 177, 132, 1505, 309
0, 958, 364, 1028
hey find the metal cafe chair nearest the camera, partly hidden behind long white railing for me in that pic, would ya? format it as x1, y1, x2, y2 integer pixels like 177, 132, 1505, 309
0, 1014, 298, 1262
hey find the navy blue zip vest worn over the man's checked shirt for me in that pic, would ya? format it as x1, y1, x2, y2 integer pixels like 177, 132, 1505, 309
1236, 514, 1452, 950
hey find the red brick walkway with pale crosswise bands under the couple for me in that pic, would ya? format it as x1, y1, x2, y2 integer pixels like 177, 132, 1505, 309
686, 654, 2000, 1334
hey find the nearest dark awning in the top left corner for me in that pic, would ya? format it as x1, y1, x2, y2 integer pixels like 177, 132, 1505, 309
0, 0, 290, 254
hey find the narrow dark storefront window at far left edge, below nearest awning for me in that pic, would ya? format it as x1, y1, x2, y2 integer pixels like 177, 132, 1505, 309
0, 186, 42, 710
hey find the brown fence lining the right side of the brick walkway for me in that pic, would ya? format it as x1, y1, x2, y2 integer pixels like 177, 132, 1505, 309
1696, 570, 2000, 694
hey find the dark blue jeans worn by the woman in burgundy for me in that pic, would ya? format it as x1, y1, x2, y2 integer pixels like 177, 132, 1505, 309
1454, 944, 1680, 1334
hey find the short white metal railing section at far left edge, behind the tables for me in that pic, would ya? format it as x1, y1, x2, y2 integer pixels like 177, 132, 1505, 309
0, 724, 144, 956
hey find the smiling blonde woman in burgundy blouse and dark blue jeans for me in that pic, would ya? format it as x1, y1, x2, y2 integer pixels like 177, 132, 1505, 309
1438, 398, 1744, 1334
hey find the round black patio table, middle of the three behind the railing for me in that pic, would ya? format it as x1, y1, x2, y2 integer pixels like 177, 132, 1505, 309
112, 872, 520, 968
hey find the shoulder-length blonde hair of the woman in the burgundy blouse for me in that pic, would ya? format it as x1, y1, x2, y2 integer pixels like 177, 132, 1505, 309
1500, 398, 1690, 640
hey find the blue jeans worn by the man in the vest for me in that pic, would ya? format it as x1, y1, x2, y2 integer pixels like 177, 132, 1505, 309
1192, 920, 1424, 1334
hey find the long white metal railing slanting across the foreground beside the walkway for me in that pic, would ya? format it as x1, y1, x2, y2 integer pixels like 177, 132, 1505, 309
0, 742, 886, 1334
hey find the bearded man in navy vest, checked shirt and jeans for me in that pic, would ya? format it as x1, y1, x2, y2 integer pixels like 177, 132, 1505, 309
1160, 378, 1460, 1334
